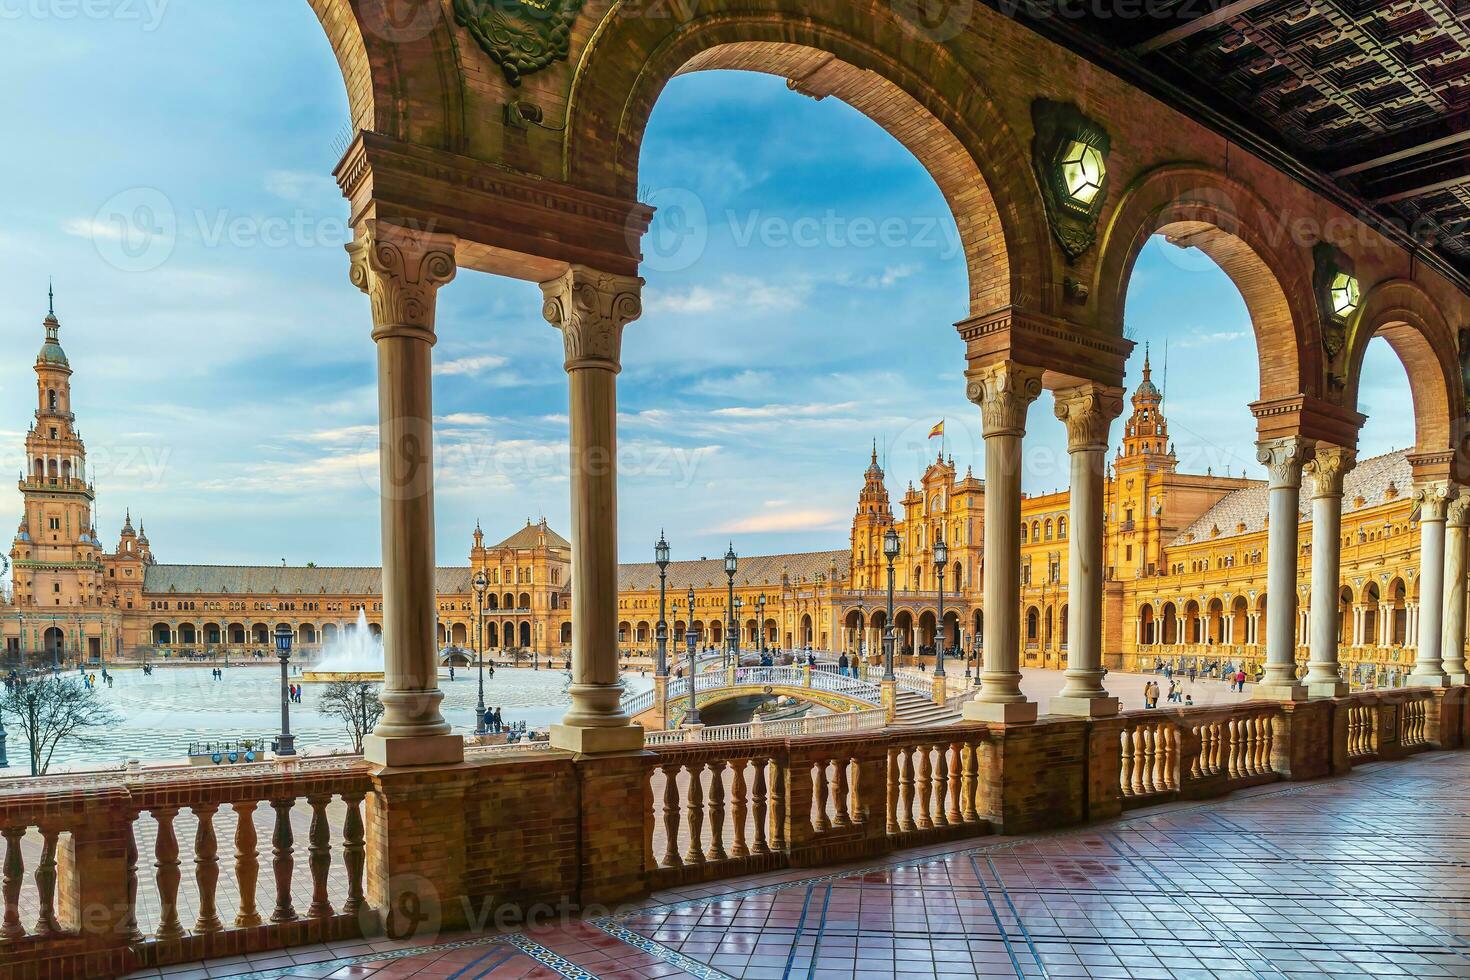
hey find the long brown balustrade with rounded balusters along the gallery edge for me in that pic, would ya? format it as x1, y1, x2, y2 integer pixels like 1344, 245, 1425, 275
0, 688, 1470, 979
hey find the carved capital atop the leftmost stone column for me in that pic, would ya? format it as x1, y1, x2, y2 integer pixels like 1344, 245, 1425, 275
347, 217, 459, 341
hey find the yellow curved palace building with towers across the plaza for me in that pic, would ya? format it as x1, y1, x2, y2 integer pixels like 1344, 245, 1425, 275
0, 310, 1446, 683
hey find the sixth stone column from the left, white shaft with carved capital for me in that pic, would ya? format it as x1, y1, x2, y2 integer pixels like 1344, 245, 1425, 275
1305, 445, 1357, 698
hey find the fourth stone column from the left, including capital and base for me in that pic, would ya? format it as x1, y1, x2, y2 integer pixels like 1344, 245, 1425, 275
1048, 383, 1123, 717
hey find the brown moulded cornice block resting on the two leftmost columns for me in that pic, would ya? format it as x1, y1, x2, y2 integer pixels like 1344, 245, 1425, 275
334, 131, 653, 282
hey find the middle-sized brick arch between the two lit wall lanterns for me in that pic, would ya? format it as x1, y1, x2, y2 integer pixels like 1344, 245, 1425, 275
1092, 165, 1323, 401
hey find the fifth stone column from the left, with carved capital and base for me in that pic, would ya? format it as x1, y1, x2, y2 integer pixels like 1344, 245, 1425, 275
1255, 436, 1308, 701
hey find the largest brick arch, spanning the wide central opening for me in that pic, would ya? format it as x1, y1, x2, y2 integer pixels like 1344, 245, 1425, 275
563, 7, 1060, 313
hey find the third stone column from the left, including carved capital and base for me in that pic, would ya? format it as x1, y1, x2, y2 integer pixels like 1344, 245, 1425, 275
964, 360, 1041, 723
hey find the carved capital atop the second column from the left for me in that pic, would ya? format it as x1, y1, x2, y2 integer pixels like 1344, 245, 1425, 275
541, 266, 644, 370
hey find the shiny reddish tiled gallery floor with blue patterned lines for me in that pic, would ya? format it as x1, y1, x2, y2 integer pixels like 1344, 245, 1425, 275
123, 752, 1470, 980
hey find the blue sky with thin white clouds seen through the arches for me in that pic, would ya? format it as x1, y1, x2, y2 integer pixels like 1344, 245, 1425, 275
0, 0, 1411, 564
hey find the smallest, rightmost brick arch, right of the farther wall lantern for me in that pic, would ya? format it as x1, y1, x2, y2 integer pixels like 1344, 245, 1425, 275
1344, 279, 1466, 453
